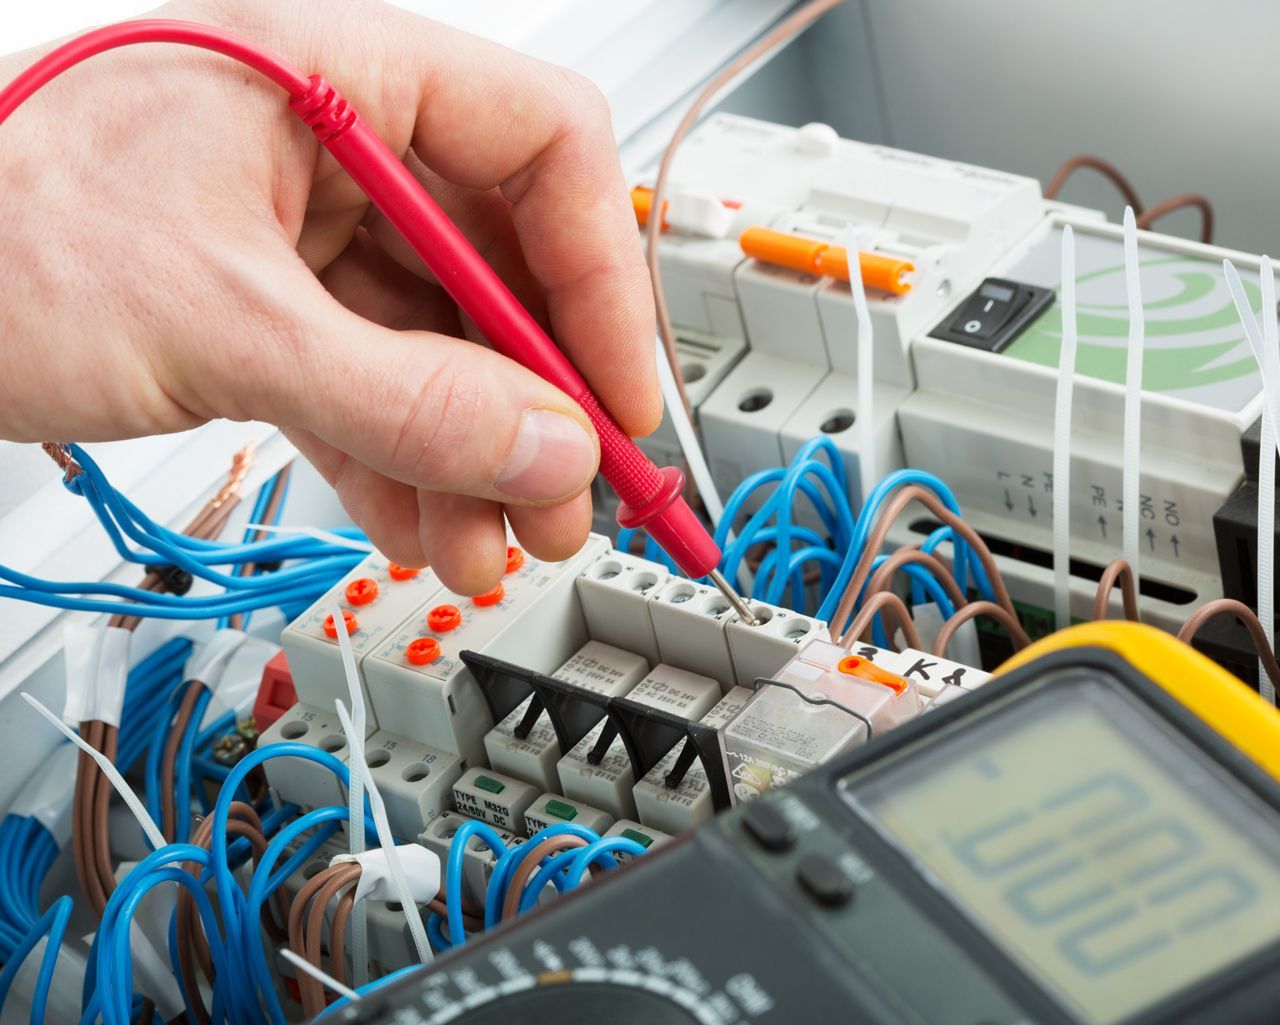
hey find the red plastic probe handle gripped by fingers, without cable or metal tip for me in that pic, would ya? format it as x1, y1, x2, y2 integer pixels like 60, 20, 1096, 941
289, 75, 721, 578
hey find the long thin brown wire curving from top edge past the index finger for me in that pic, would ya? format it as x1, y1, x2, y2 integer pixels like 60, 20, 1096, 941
645, 0, 841, 418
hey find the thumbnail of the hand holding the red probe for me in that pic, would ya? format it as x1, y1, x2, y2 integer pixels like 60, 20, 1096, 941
493, 409, 595, 502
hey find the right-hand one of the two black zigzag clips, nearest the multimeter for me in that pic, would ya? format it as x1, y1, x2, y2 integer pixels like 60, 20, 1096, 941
609, 697, 731, 811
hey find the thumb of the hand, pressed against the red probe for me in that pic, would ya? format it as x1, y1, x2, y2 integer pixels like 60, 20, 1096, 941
185, 279, 599, 505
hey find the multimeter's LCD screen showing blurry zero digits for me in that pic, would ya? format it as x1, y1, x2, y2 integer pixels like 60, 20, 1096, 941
849, 671, 1280, 1025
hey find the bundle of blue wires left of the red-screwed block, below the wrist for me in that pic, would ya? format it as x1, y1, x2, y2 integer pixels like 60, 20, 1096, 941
0, 445, 365, 619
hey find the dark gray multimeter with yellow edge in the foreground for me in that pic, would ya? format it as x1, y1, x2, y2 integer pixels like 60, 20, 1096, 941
332, 623, 1280, 1025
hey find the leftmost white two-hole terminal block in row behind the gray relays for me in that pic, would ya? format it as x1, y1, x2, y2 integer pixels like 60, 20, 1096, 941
577, 549, 671, 665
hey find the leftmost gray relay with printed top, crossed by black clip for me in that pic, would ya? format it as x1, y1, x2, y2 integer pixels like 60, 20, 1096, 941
484, 641, 649, 792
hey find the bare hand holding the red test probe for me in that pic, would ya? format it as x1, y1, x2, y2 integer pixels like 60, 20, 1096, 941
0, 0, 662, 594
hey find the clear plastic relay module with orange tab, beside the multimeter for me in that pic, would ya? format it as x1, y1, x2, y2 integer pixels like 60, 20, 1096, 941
721, 641, 920, 802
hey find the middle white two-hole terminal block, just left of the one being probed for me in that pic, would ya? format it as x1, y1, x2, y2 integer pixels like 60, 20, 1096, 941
649, 578, 736, 692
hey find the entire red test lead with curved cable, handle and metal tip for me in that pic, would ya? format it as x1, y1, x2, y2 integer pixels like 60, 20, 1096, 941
0, 19, 756, 626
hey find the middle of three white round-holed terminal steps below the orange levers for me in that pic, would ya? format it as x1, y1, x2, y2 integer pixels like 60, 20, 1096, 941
698, 352, 827, 511
